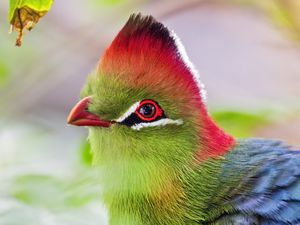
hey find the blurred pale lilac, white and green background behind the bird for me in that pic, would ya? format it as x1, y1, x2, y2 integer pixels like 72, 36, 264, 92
0, 0, 300, 225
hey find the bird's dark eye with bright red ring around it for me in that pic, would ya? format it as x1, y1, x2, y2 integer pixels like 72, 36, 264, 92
136, 100, 163, 121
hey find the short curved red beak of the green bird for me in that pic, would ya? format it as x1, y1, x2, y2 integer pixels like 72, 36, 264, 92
67, 96, 112, 127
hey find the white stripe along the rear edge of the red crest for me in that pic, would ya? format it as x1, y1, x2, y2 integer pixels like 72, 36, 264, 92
171, 31, 206, 101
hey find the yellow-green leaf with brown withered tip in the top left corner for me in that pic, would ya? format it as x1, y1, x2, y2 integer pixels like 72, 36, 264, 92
8, 0, 53, 46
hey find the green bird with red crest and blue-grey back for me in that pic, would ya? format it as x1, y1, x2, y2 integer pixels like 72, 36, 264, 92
67, 13, 300, 225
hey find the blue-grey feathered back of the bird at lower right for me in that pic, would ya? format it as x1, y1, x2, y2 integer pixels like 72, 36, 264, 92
213, 139, 300, 225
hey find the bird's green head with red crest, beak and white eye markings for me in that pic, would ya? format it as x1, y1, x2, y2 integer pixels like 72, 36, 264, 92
68, 14, 234, 192
